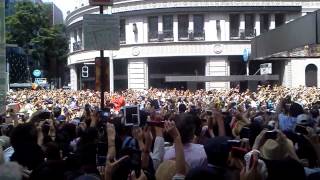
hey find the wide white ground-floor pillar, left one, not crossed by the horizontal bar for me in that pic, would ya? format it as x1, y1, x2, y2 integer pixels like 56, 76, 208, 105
128, 58, 149, 90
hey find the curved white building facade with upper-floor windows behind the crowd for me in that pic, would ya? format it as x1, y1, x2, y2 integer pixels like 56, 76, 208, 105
65, 0, 320, 91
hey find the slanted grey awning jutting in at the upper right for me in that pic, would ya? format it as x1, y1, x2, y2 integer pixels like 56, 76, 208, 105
250, 10, 320, 60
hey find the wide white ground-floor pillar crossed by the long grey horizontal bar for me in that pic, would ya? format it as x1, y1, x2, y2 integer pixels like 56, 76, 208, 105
206, 56, 230, 91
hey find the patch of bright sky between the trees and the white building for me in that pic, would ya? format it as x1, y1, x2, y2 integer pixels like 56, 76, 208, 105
42, 0, 88, 19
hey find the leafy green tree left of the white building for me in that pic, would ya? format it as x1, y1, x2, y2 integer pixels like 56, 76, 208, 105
6, 1, 68, 86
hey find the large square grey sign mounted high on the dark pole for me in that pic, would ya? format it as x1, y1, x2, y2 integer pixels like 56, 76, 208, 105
83, 14, 120, 50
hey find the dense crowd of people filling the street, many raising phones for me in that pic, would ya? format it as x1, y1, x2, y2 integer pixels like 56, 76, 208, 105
0, 86, 320, 180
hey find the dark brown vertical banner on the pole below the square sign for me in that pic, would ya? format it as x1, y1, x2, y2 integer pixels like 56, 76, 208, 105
95, 57, 110, 92
